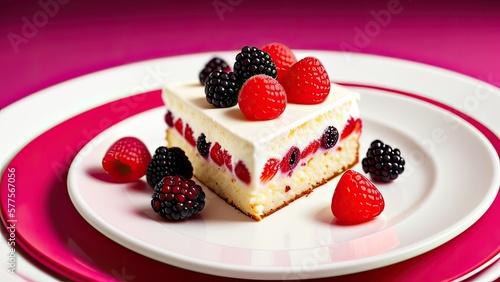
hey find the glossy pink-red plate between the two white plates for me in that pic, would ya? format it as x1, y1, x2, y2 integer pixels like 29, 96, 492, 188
1, 85, 500, 281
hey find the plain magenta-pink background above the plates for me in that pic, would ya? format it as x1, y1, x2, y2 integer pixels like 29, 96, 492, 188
0, 0, 500, 108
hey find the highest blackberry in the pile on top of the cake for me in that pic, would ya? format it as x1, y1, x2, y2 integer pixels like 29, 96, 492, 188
233, 46, 278, 81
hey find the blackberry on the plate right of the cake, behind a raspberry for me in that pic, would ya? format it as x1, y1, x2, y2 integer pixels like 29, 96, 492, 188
361, 139, 405, 182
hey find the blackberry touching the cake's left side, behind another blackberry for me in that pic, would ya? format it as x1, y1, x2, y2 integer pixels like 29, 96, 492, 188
146, 146, 193, 188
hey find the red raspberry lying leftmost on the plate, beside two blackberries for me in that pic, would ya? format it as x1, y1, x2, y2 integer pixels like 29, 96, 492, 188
102, 137, 151, 183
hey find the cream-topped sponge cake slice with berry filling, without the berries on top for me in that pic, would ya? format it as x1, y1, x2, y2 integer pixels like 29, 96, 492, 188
162, 82, 362, 221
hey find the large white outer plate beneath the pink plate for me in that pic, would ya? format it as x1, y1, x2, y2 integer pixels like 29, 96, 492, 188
0, 50, 500, 281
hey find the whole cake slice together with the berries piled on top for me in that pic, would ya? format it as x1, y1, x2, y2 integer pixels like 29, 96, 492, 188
162, 44, 362, 221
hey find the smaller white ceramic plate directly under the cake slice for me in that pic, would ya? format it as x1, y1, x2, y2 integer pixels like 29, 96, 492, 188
68, 86, 500, 279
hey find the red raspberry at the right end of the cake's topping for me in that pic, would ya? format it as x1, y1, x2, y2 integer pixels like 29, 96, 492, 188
280, 57, 331, 104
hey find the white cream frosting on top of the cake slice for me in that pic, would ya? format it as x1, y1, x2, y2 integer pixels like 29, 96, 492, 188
163, 82, 360, 191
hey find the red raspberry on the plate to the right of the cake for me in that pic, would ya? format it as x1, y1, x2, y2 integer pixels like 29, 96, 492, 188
331, 170, 385, 224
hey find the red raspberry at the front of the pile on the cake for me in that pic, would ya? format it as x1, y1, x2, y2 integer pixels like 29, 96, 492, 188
238, 74, 286, 120
